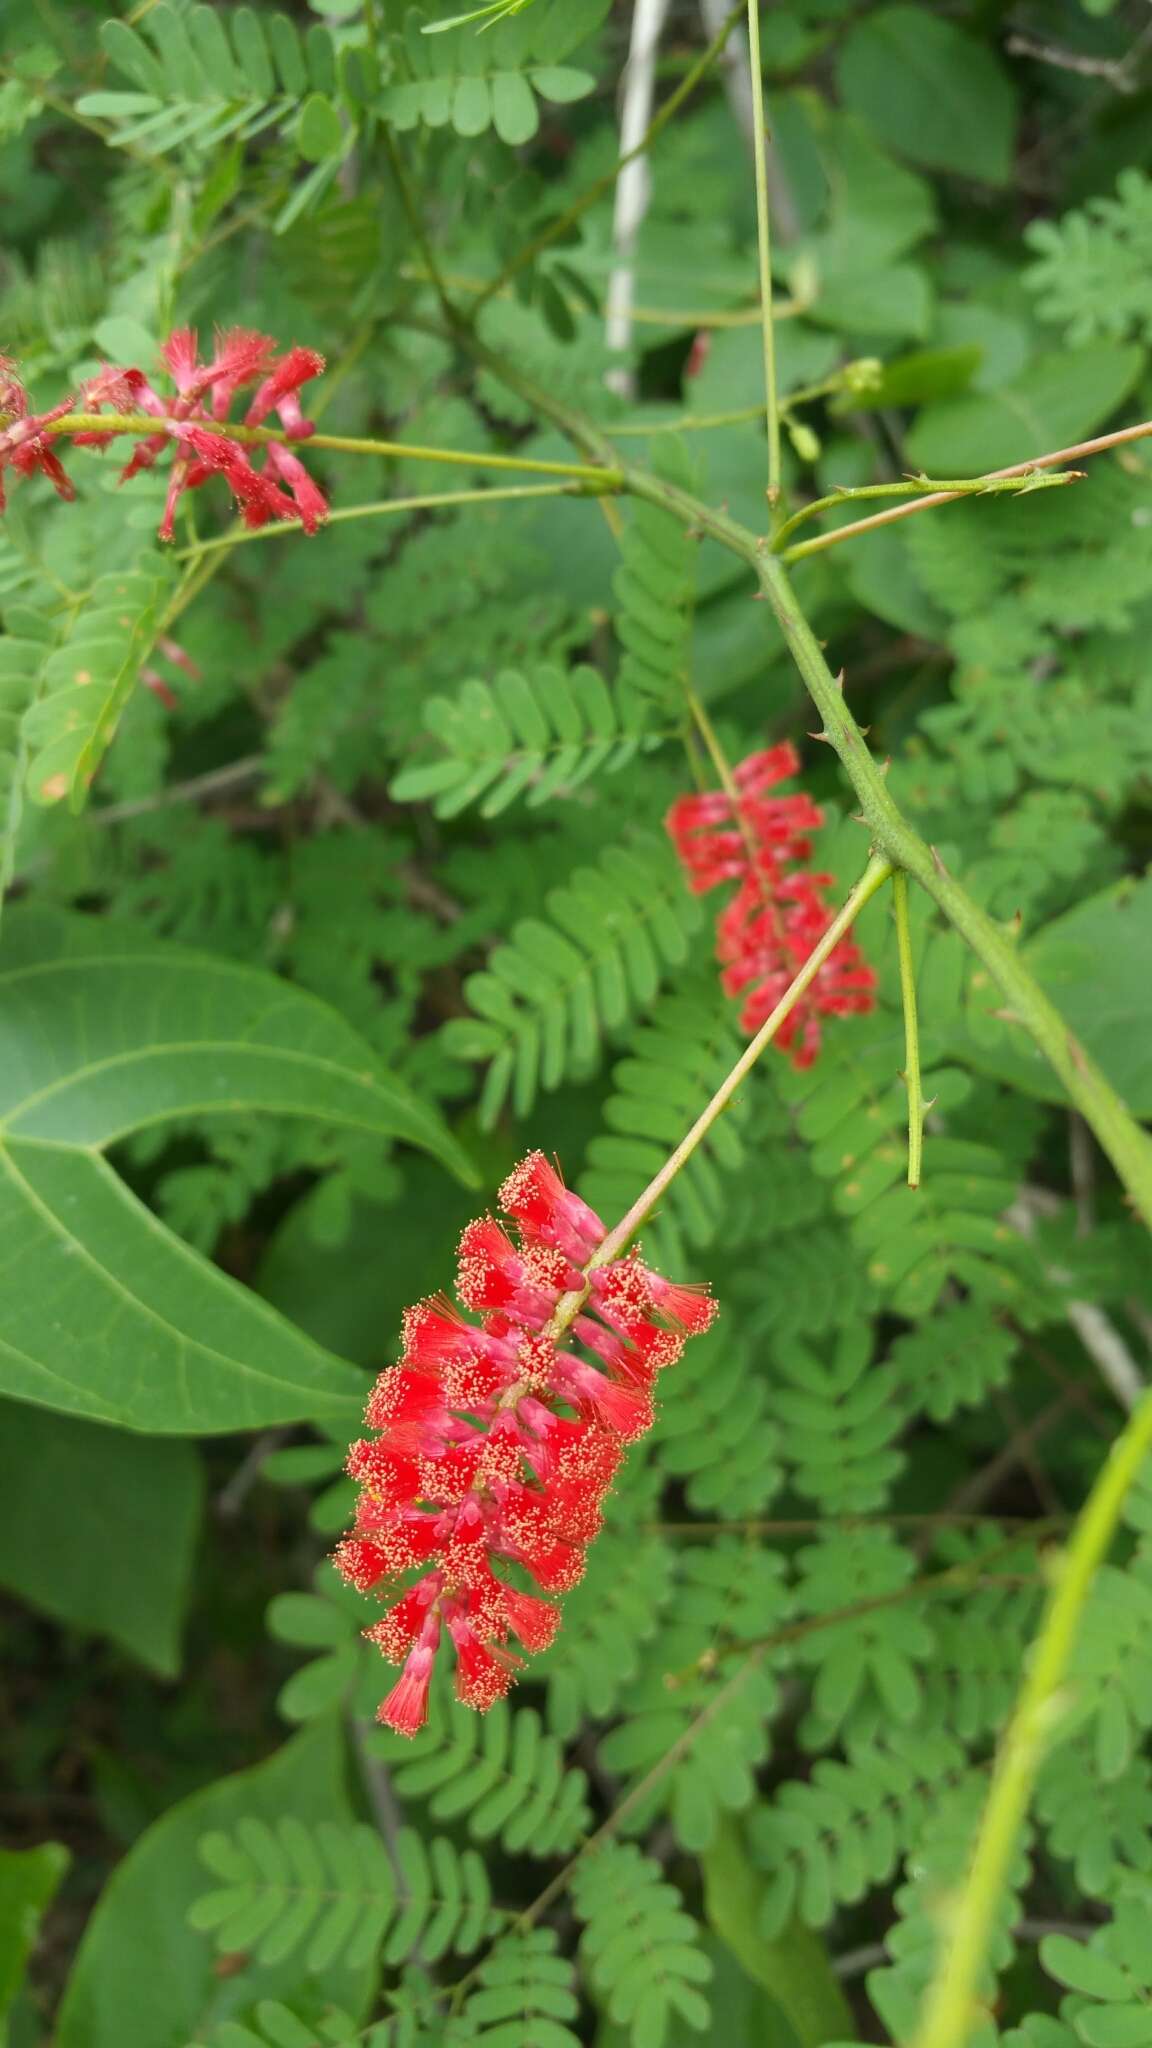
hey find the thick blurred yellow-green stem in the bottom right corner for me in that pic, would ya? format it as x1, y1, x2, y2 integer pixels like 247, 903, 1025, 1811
912, 1395, 1152, 2048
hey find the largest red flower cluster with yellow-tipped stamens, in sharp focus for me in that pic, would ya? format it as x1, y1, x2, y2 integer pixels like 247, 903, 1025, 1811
336, 1151, 715, 1735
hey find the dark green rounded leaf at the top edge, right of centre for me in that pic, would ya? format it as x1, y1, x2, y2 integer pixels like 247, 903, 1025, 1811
838, 6, 1017, 184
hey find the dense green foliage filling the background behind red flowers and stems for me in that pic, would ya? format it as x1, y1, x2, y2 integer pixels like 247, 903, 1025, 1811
0, 0, 1152, 2048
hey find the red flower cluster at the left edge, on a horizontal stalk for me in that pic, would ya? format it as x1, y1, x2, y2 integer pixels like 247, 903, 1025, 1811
0, 328, 328, 541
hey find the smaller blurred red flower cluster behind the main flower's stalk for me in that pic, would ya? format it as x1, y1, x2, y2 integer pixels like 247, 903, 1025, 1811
664, 741, 875, 1067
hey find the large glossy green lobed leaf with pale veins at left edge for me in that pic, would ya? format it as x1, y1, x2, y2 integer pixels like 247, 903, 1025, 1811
0, 915, 471, 1434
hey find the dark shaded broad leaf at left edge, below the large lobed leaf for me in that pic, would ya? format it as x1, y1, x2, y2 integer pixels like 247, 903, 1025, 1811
0, 1401, 203, 1677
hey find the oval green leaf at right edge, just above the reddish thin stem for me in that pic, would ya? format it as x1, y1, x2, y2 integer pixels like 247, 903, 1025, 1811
904, 342, 1144, 477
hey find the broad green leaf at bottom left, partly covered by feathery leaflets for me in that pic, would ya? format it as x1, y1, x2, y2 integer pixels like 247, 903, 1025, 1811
53, 1718, 373, 2048
